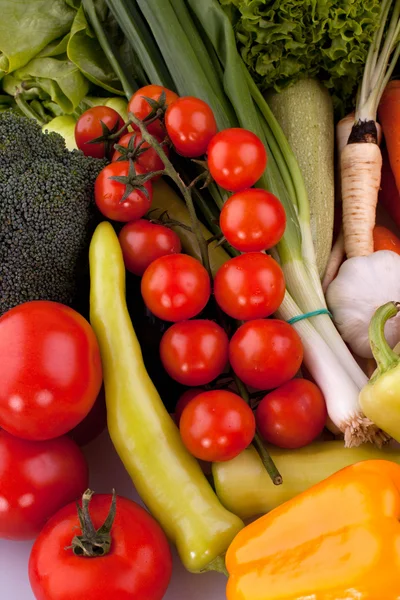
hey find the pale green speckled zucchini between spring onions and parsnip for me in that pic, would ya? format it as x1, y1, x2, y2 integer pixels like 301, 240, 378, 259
266, 79, 335, 278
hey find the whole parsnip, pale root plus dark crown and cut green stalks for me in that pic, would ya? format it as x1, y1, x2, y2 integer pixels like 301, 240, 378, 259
340, 0, 400, 258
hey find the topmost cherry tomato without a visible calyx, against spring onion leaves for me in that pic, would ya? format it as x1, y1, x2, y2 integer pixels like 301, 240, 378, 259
165, 96, 217, 158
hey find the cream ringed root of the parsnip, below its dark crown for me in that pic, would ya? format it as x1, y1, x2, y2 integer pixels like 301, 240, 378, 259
341, 142, 382, 258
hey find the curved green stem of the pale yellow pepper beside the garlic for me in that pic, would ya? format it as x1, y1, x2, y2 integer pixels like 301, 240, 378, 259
368, 302, 400, 373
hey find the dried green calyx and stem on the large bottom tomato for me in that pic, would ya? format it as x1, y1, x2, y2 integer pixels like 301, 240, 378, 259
66, 489, 117, 558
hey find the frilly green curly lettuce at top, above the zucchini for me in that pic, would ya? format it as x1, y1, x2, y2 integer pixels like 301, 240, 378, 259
220, 0, 381, 110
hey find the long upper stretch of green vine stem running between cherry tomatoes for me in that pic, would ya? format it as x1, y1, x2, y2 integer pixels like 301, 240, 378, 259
128, 113, 212, 279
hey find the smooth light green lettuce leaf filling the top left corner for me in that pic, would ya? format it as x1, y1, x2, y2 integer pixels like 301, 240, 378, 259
0, 0, 75, 73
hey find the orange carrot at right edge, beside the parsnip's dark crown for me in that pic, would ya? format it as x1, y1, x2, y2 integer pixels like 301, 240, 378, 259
378, 81, 400, 193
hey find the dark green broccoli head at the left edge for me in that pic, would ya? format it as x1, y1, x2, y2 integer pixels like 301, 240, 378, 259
0, 111, 106, 315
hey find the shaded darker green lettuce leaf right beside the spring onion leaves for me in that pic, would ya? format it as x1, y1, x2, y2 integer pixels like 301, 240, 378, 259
67, 6, 123, 94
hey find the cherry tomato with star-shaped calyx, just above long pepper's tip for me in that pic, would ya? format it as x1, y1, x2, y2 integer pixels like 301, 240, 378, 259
94, 161, 153, 222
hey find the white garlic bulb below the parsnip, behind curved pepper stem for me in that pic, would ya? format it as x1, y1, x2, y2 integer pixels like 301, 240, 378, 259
326, 250, 400, 358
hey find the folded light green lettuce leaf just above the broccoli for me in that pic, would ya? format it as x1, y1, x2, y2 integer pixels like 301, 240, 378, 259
2, 57, 89, 114
